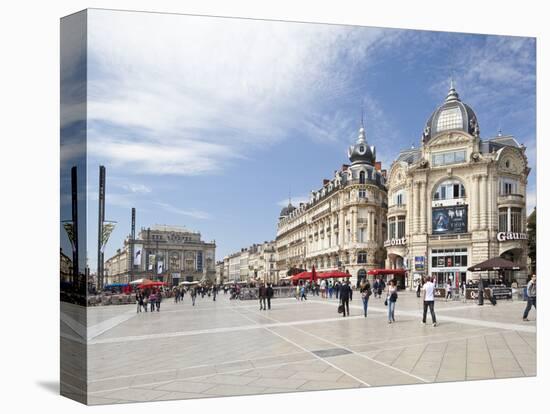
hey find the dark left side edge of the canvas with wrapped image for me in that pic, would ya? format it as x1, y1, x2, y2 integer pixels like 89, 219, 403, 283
59, 11, 89, 404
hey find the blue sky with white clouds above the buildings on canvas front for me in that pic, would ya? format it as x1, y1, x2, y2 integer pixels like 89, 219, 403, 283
75, 10, 536, 271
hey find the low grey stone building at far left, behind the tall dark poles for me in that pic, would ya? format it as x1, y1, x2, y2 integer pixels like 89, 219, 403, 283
105, 225, 216, 284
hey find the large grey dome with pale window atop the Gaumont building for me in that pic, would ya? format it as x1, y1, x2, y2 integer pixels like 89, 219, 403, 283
422, 82, 479, 143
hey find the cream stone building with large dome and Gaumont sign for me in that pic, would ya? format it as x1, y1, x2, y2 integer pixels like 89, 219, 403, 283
385, 84, 530, 286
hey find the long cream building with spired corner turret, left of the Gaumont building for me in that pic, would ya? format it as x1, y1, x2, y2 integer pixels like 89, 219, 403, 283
276, 121, 387, 283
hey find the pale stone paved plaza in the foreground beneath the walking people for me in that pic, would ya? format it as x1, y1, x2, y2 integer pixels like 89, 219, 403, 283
62, 292, 536, 404
